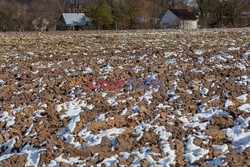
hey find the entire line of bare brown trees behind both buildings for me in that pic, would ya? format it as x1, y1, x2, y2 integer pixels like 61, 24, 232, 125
0, 0, 250, 31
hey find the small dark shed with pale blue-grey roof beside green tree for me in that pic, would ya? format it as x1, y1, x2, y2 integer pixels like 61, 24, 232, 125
56, 13, 91, 30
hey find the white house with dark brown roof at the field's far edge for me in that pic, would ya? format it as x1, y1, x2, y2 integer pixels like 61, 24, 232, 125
160, 9, 198, 29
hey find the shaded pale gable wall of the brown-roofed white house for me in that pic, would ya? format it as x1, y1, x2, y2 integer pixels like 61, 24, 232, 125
160, 10, 179, 29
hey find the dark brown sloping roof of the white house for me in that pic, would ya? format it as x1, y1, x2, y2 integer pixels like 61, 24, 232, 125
169, 9, 197, 20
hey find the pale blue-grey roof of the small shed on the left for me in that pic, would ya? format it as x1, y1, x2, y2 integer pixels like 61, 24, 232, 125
61, 13, 90, 26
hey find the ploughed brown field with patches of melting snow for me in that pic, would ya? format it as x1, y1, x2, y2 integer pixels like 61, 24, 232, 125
0, 28, 250, 167
